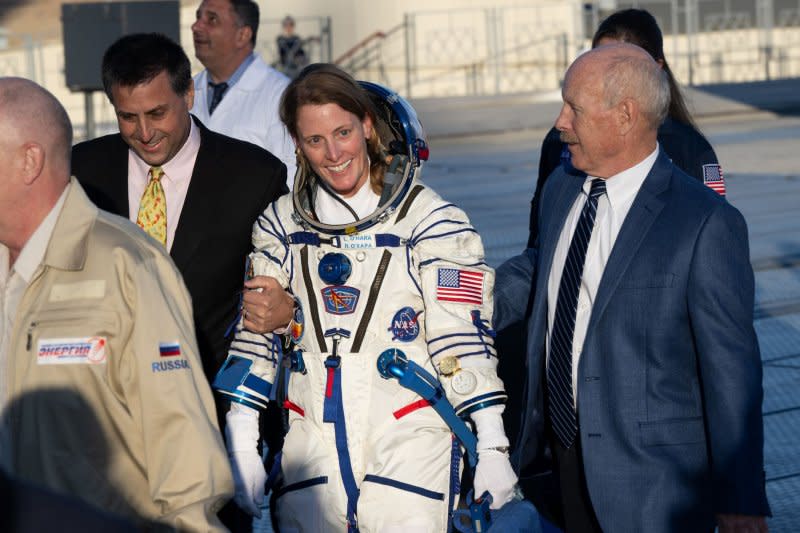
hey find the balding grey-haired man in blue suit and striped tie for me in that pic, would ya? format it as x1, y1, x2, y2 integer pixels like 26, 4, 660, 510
495, 44, 770, 533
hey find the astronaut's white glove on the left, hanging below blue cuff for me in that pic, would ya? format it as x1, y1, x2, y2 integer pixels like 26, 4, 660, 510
225, 403, 267, 518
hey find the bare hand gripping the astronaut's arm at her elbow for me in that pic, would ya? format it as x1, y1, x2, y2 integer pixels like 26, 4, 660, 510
242, 276, 294, 333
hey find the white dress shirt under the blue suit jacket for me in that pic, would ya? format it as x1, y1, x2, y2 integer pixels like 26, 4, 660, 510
547, 145, 659, 406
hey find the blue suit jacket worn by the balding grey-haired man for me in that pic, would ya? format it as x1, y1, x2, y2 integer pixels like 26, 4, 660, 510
495, 152, 769, 533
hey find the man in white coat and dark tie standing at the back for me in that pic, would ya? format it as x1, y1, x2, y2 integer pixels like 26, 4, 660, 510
192, 0, 297, 189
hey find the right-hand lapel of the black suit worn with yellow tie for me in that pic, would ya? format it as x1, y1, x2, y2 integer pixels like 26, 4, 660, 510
170, 117, 219, 271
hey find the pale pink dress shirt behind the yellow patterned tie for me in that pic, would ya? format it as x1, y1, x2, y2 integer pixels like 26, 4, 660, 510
128, 120, 200, 251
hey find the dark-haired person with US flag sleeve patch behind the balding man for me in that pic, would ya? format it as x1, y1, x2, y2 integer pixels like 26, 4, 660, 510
528, 9, 725, 247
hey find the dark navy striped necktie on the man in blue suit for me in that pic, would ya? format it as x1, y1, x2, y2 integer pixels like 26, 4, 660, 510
547, 179, 606, 448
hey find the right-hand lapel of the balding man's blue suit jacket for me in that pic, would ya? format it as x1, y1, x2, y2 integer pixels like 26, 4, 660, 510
586, 151, 673, 332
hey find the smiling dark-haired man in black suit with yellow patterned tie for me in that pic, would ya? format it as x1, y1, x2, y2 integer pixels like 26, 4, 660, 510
72, 34, 286, 381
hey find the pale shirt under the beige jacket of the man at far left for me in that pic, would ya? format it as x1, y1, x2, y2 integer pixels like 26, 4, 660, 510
0, 184, 70, 409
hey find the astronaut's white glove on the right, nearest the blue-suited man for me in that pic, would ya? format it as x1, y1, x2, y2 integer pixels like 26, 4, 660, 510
471, 405, 517, 509
